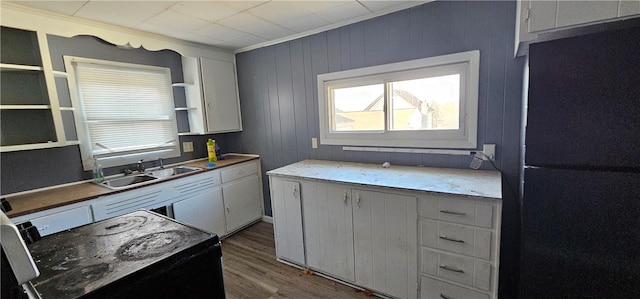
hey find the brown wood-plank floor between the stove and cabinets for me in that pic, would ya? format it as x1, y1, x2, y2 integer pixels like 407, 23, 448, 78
222, 222, 376, 299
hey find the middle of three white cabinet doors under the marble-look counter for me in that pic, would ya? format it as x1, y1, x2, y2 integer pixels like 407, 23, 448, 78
301, 182, 355, 281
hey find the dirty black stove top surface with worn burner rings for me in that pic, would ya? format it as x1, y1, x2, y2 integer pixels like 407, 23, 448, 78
28, 211, 218, 299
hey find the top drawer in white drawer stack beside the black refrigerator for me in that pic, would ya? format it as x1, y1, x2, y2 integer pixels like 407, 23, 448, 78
420, 194, 494, 228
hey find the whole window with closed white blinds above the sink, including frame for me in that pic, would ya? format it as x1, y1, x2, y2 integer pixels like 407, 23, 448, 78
65, 56, 180, 170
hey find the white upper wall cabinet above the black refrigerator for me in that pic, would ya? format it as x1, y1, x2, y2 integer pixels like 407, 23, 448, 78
515, 0, 640, 55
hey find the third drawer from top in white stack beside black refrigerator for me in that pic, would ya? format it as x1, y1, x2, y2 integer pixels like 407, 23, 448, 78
421, 248, 491, 291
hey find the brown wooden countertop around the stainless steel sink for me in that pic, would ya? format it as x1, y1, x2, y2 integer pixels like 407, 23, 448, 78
5, 154, 259, 217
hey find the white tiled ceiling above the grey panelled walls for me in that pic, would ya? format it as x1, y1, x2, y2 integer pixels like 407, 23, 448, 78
6, 0, 426, 52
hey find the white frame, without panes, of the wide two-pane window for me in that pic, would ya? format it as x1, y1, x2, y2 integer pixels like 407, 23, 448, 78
317, 50, 480, 149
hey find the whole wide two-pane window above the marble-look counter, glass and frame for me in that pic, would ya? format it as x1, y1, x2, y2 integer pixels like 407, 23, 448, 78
318, 51, 480, 149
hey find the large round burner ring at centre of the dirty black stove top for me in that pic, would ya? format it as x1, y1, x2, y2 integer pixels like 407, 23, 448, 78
116, 230, 187, 261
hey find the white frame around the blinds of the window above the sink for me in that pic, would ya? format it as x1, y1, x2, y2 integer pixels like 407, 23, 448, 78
64, 55, 180, 170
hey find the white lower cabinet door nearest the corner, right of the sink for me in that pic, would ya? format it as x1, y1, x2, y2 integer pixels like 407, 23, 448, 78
222, 175, 262, 232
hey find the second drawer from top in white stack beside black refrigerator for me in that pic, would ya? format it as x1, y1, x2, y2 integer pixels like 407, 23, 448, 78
420, 219, 493, 260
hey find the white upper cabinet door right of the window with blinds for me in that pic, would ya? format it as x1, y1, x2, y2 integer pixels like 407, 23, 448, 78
200, 58, 242, 133
